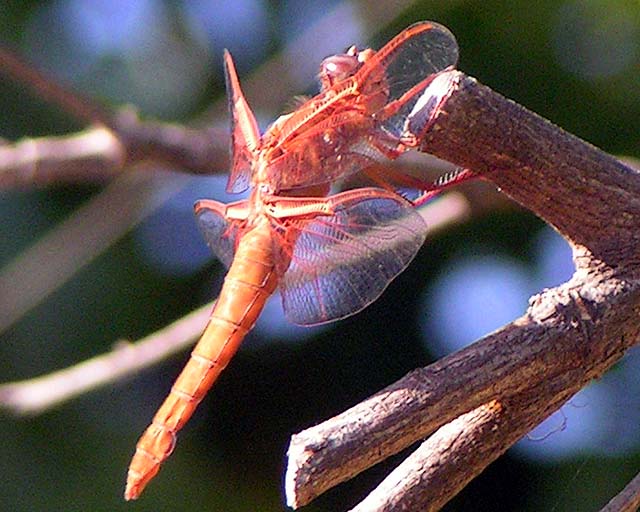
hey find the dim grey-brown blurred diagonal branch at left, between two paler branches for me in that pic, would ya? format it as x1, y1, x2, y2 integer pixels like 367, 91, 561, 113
0, 172, 181, 332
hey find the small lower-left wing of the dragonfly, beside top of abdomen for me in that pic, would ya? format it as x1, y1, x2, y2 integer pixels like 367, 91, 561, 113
195, 200, 239, 268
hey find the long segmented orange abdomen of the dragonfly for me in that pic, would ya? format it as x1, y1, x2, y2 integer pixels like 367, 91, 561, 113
125, 217, 277, 500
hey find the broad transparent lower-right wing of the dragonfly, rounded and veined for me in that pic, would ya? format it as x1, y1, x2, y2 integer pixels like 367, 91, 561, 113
280, 188, 426, 325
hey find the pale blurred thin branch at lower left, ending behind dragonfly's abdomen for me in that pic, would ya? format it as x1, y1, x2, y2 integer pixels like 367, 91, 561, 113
0, 304, 213, 414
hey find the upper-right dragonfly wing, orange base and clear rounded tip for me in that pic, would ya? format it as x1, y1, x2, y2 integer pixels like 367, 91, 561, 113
264, 22, 458, 190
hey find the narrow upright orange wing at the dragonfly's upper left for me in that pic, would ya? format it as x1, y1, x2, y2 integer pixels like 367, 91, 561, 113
224, 50, 260, 193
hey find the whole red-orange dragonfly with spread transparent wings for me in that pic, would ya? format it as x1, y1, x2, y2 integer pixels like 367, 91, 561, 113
125, 22, 457, 500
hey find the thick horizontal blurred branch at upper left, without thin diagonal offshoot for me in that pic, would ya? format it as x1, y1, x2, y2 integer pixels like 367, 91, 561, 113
0, 113, 229, 189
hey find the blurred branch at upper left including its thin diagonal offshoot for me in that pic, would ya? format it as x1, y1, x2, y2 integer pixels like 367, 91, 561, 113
0, 47, 229, 188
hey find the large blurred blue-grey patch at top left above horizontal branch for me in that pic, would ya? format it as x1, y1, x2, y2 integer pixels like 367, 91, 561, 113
25, 0, 211, 117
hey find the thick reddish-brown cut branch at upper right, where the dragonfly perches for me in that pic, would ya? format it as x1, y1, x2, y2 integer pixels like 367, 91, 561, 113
421, 71, 640, 274
